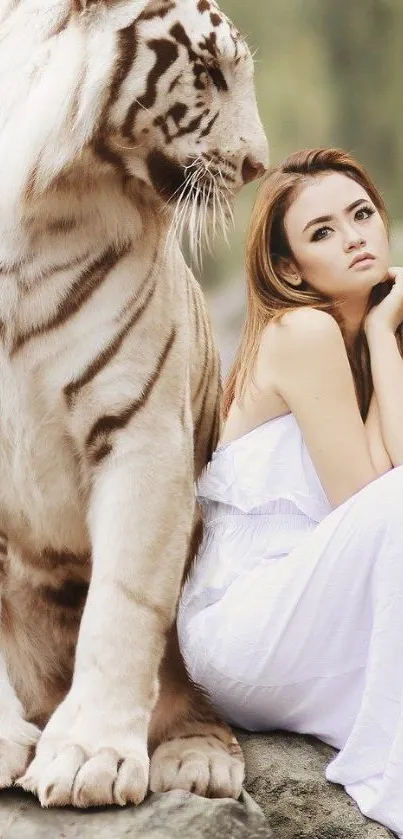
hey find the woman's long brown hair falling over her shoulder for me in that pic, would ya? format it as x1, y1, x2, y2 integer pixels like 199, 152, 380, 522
224, 148, 389, 418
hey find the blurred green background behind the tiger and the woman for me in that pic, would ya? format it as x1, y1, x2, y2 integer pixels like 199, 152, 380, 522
201, 0, 403, 372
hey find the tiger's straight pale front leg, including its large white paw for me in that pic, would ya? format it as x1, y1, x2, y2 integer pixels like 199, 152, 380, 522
20, 440, 194, 807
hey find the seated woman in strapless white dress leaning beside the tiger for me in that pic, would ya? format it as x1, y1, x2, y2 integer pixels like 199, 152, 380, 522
178, 149, 403, 837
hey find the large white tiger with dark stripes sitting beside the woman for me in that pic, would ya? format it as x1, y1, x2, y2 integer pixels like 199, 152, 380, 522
0, 0, 267, 807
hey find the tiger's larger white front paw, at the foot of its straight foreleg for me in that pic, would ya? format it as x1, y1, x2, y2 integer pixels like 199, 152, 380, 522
17, 697, 149, 808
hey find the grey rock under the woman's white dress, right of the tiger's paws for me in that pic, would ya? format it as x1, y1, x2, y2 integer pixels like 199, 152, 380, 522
237, 732, 394, 839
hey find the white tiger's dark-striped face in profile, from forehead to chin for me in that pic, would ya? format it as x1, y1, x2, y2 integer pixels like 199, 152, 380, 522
73, 0, 268, 223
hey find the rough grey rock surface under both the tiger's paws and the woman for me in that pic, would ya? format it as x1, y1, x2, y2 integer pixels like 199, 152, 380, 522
0, 732, 393, 839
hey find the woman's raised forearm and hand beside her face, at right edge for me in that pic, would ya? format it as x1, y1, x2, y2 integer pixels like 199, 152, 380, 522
365, 268, 403, 466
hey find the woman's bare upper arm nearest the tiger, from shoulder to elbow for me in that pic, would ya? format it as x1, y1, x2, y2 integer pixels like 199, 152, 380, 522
260, 309, 386, 506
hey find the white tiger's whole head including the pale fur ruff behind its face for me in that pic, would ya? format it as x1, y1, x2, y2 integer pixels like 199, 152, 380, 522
0, 0, 268, 243
